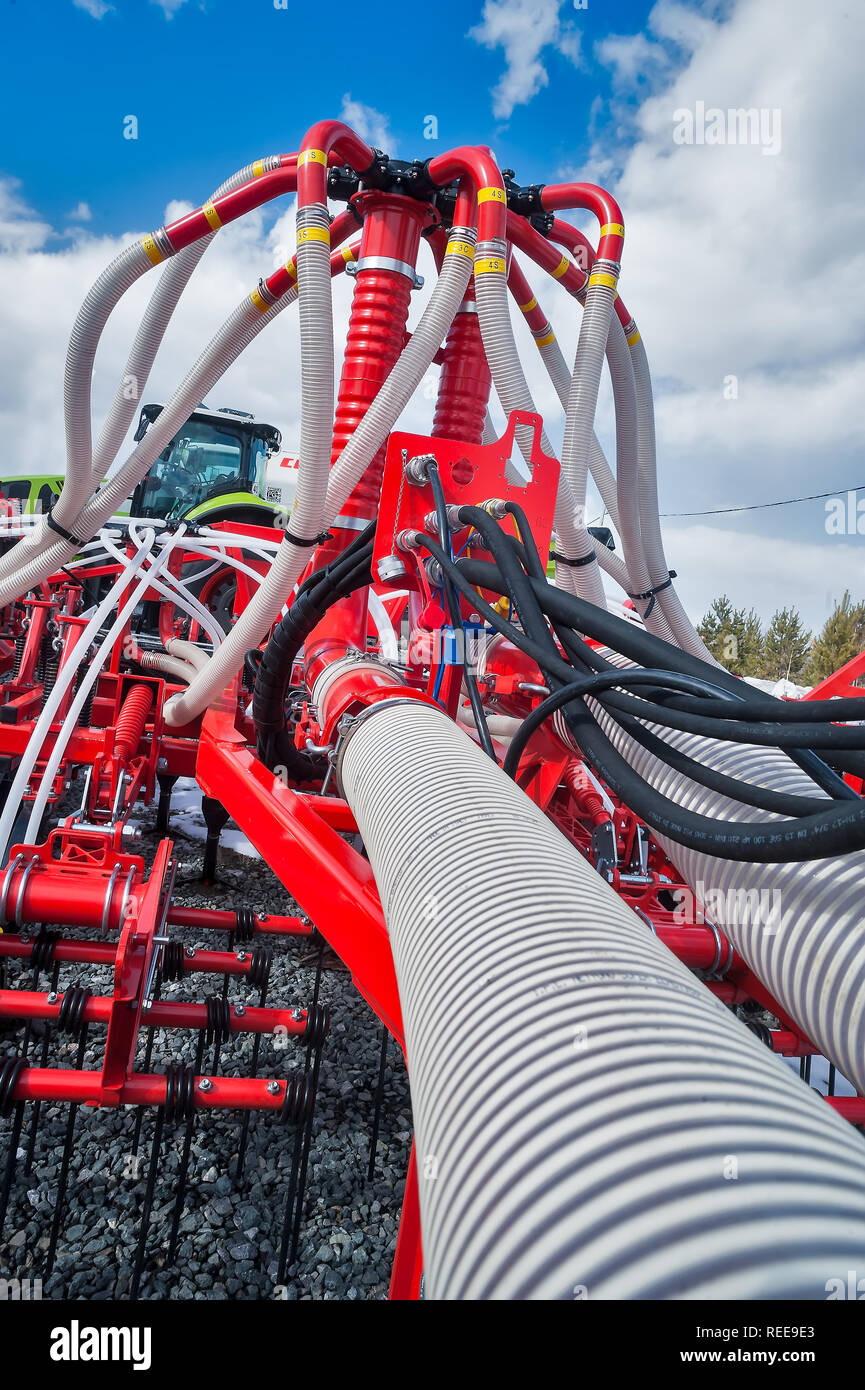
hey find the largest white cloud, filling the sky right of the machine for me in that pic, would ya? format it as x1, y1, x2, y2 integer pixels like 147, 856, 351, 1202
561, 0, 865, 623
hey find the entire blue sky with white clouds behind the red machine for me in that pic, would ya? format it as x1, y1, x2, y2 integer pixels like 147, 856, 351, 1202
0, 0, 865, 626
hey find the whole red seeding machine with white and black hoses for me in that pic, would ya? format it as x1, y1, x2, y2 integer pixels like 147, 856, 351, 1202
0, 121, 865, 1300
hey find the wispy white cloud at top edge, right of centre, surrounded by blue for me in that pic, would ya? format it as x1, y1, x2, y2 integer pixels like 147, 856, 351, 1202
469, 0, 580, 121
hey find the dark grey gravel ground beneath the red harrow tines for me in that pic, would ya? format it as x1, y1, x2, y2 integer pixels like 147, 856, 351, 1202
0, 789, 412, 1300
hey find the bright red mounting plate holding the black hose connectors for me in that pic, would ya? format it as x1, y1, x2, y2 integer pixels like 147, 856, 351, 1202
373, 410, 559, 589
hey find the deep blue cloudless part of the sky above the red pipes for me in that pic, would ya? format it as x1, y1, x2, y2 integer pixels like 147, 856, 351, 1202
0, 0, 661, 232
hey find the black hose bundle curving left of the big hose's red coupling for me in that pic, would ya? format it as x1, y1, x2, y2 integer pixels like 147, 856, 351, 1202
252, 541, 373, 781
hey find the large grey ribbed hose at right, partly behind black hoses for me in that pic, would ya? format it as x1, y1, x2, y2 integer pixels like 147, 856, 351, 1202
595, 683, 865, 1091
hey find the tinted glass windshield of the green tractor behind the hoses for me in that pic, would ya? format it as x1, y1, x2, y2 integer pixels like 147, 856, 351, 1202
139, 420, 249, 520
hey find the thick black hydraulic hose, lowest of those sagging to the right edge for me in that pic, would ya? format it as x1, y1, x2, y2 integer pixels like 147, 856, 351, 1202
423, 537, 865, 863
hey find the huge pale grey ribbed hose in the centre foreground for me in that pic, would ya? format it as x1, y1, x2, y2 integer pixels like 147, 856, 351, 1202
341, 702, 865, 1300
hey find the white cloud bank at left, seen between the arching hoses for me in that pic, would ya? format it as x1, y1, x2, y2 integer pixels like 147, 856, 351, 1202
0, 173, 434, 492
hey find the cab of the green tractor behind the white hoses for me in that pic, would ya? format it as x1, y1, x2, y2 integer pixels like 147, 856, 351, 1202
131, 404, 282, 525
